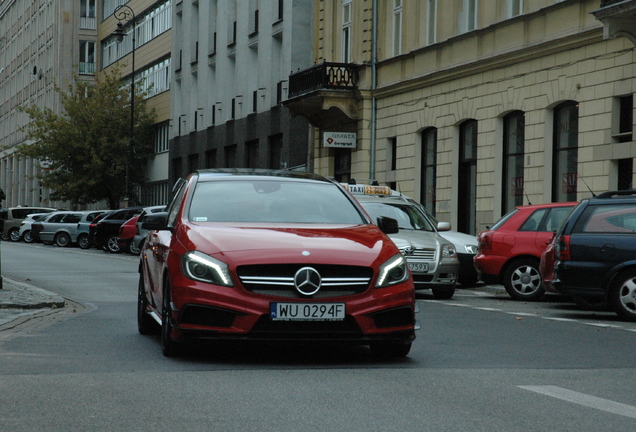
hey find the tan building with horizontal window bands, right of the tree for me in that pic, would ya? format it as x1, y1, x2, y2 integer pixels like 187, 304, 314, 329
98, 0, 174, 205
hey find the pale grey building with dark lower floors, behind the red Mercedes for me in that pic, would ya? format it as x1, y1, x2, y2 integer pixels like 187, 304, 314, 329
170, 0, 314, 181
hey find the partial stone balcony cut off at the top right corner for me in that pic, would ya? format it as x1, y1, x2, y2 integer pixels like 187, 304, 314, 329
591, 0, 636, 45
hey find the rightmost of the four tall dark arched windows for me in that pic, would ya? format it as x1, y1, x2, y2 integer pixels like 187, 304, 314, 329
552, 101, 579, 202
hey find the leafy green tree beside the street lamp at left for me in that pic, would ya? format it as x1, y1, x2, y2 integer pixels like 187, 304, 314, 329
18, 67, 155, 209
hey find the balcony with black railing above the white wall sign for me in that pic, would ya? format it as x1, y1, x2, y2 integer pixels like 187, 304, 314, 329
283, 63, 360, 128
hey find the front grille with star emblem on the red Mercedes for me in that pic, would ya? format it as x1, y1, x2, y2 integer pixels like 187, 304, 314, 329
236, 264, 373, 299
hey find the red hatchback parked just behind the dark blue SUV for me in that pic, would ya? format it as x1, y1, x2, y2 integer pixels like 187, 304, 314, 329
473, 202, 576, 300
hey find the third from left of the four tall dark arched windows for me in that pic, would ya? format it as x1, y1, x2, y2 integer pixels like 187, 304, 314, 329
501, 111, 525, 214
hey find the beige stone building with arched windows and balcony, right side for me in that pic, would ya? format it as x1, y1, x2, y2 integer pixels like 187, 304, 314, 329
285, 0, 636, 234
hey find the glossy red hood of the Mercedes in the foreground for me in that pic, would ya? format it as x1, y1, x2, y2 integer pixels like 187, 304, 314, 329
182, 224, 398, 266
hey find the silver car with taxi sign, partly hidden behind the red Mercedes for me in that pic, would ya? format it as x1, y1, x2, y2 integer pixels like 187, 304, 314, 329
350, 189, 459, 299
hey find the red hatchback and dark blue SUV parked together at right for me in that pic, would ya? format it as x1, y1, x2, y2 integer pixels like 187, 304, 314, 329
474, 190, 636, 321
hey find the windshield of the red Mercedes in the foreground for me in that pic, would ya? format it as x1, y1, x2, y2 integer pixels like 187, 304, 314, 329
188, 178, 367, 225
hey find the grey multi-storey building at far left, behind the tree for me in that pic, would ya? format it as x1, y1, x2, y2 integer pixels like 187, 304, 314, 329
0, 0, 97, 207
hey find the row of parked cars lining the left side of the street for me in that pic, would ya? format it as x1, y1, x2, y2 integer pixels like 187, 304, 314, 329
3, 206, 165, 254
